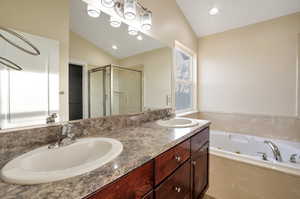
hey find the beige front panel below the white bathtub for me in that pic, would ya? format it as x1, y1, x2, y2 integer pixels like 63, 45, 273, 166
207, 155, 300, 199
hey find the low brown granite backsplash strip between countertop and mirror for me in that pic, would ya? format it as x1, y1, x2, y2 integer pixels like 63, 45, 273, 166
0, 108, 172, 167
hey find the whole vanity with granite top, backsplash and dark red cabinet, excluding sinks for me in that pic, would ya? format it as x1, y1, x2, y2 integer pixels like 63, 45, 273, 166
0, 109, 210, 199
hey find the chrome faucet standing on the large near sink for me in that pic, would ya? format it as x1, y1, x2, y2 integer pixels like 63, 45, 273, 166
48, 123, 76, 149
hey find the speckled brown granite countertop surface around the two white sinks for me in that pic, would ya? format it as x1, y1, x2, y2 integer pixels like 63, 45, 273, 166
0, 120, 210, 199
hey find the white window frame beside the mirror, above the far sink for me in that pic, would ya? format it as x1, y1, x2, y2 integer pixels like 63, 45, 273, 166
172, 41, 198, 116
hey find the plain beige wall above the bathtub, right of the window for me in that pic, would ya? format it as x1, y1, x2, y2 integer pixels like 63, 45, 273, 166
198, 13, 300, 116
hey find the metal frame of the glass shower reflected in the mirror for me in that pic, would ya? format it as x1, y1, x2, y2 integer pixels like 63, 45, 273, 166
88, 64, 144, 118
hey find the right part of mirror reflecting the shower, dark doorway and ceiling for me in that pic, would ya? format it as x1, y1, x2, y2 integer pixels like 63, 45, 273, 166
69, 1, 172, 120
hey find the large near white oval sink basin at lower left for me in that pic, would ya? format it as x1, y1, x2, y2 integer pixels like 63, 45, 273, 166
1, 138, 123, 184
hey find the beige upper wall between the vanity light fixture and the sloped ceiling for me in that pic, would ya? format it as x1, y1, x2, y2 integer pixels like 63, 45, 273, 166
140, 0, 198, 52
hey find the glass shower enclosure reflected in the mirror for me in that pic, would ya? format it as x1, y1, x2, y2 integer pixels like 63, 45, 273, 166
88, 65, 143, 118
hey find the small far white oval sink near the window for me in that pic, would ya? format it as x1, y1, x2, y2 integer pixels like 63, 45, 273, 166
157, 118, 198, 128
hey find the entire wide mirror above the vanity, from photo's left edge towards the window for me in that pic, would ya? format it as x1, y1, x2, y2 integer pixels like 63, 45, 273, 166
0, 0, 173, 132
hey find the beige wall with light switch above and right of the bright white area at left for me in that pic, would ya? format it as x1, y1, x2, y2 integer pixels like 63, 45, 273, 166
0, 0, 69, 119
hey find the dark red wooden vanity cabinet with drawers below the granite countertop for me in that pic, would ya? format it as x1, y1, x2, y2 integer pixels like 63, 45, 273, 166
85, 128, 209, 199
